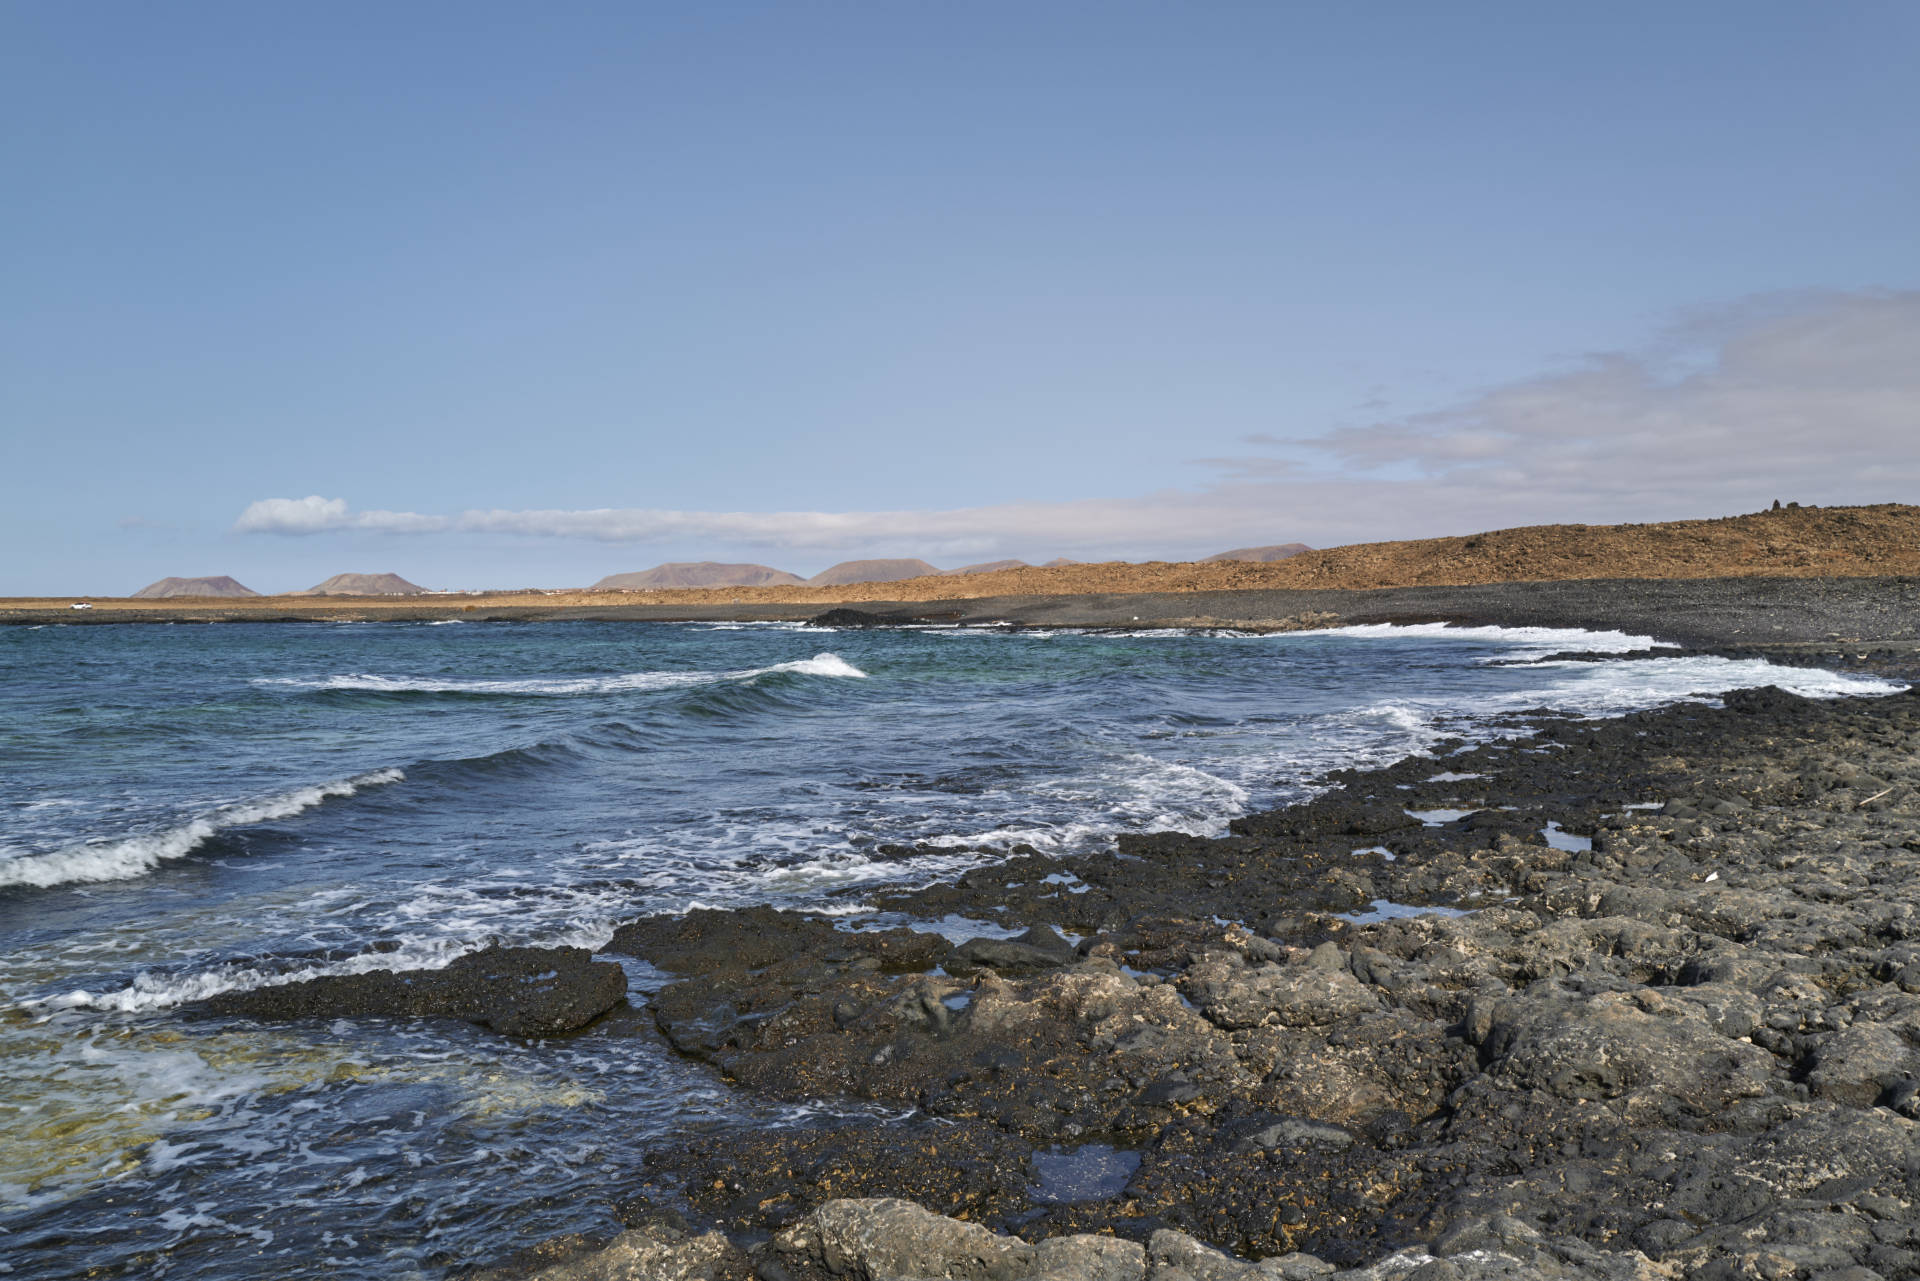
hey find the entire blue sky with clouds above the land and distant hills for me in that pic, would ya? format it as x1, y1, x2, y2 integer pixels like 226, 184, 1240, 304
0, 0, 1920, 595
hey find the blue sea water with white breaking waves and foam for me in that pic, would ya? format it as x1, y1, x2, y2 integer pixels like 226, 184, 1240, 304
0, 622, 1893, 1277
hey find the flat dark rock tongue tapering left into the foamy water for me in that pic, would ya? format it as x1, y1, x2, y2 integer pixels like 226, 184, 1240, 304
188, 947, 626, 1037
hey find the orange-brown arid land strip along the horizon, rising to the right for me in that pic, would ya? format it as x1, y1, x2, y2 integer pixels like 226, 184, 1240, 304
15, 503, 1920, 622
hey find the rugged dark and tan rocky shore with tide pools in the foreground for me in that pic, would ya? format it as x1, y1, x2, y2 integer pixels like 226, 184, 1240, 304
487, 676, 1920, 1281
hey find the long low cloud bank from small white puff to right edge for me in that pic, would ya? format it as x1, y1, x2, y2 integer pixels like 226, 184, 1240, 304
234, 292, 1920, 559
